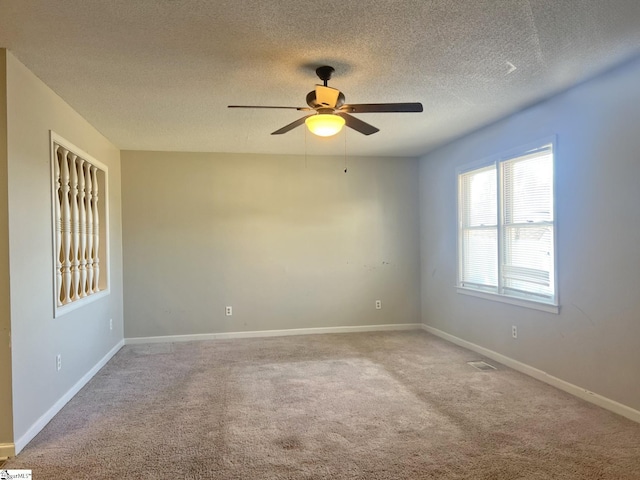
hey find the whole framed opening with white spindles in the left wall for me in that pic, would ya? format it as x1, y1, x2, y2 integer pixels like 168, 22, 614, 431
51, 132, 109, 316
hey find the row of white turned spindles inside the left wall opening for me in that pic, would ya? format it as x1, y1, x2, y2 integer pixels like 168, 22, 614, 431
53, 143, 100, 307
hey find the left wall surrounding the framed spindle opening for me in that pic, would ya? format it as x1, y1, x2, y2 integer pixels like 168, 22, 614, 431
7, 53, 123, 442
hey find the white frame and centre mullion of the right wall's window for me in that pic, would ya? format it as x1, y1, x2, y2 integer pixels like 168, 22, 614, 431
456, 135, 560, 314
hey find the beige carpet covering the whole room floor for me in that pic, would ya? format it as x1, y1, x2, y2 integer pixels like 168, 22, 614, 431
6, 332, 640, 480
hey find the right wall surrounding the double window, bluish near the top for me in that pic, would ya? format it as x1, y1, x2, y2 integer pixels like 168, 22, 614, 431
420, 55, 640, 410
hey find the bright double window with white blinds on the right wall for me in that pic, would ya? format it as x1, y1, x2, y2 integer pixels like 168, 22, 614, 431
458, 143, 557, 312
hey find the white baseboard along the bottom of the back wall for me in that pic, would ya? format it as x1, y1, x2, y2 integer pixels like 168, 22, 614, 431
124, 323, 422, 345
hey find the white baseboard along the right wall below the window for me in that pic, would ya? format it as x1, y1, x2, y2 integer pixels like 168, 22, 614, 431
422, 325, 640, 423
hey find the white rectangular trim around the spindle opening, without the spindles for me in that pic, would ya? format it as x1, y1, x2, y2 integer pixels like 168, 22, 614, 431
49, 130, 111, 318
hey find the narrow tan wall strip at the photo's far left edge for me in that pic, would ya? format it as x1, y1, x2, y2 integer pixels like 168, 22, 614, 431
0, 49, 13, 457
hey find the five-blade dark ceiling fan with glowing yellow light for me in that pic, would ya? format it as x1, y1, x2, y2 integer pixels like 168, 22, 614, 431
229, 65, 422, 137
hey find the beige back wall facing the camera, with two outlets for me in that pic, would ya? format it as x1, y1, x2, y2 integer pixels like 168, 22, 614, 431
122, 151, 420, 338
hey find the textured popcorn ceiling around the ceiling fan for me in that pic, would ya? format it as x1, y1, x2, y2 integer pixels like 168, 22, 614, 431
0, 0, 640, 156
